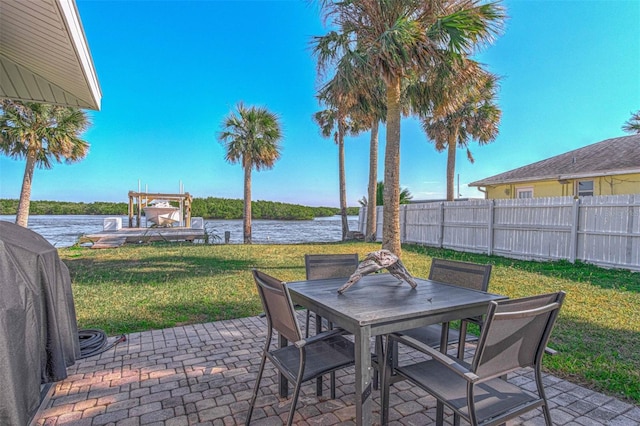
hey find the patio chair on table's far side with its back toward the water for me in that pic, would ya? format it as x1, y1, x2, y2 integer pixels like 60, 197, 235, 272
304, 253, 360, 399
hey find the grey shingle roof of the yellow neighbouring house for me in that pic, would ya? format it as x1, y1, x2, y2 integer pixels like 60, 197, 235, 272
469, 134, 640, 186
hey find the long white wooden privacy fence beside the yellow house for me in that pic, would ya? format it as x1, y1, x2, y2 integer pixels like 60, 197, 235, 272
359, 194, 640, 270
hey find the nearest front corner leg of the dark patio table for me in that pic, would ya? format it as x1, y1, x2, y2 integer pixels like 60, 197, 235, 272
354, 327, 373, 426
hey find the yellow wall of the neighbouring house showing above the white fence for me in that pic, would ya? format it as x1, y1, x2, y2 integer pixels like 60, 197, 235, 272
486, 173, 640, 199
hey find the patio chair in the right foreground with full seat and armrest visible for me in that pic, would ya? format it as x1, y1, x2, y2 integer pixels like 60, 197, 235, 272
381, 291, 565, 426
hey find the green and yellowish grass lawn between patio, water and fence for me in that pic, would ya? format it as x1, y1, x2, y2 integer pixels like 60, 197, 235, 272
59, 243, 640, 405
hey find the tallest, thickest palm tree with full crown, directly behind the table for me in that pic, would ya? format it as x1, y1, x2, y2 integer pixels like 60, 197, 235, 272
320, 0, 504, 255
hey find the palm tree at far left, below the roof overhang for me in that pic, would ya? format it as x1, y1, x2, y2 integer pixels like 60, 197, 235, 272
0, 99, 90, 228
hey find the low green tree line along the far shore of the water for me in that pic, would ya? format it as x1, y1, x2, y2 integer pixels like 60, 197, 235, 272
0, 197, 358, 220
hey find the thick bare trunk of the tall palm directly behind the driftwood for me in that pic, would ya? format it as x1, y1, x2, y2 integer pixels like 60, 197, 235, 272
382, 76, 401, 257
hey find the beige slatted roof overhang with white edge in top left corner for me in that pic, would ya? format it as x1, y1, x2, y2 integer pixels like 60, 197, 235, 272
0, 0, 102, 110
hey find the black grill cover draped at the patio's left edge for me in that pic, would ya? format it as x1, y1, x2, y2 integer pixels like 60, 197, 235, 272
0, 221, 80, 426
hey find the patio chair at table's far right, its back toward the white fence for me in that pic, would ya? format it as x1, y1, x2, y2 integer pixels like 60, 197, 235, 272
392, 258, 491, 359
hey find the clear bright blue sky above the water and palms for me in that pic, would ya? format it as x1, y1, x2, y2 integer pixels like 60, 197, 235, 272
0, 0, 640, 206
